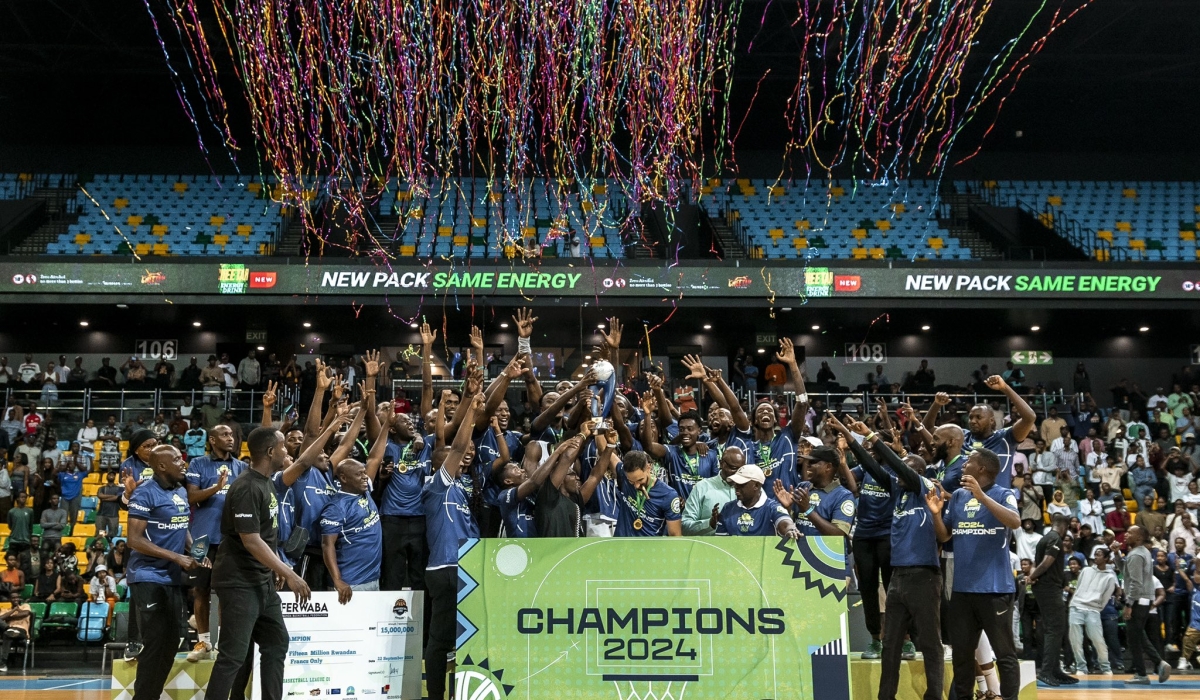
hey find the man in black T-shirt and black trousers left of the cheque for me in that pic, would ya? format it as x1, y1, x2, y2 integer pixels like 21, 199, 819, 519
204, 427, 310, 700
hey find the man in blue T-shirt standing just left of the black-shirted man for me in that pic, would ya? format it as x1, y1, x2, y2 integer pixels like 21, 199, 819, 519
187, 424, 246, 662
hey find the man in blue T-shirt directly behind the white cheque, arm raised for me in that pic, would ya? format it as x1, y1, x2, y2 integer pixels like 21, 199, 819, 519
320, 403, 391, 605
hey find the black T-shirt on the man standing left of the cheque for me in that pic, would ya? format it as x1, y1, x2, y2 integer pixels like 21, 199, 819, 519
212, 469, 280, 588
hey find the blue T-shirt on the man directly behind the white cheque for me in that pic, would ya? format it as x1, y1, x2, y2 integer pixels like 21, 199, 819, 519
320, 489, 383, 586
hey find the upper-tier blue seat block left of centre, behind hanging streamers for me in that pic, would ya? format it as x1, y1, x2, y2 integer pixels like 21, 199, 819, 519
379, 178, 629, 258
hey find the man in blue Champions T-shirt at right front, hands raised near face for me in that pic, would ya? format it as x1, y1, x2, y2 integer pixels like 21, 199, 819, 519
925, 448, 1021, 700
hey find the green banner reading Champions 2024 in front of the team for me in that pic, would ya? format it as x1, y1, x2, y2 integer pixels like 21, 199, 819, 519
455, 537, 850, 700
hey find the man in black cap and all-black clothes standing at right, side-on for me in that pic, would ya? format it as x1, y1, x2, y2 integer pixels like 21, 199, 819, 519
1030, 513, 1079, 687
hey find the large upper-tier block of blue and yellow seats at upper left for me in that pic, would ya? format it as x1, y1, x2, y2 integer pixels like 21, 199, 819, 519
46, 175, 281, 256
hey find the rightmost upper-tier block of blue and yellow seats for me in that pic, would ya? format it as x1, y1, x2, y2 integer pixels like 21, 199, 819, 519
983, 180, 1200, 262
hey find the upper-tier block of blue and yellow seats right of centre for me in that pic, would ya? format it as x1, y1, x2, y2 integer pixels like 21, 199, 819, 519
702, 179, 972, 261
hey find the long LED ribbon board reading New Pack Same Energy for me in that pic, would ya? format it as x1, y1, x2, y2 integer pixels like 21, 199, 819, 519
0, 257, 1200, 304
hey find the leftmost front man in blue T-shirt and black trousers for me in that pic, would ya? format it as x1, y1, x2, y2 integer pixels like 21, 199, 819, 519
125, 445, 208, 700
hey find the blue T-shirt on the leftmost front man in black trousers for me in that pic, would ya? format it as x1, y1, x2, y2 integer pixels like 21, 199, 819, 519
125, 479, 188, 586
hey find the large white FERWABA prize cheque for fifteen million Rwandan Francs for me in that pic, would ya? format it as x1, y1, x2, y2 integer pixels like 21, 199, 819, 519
252, 591, 425, 700
